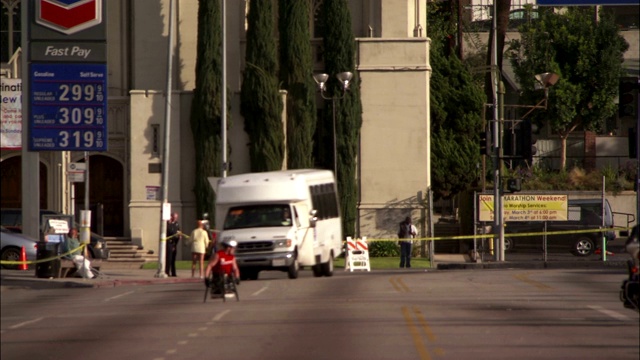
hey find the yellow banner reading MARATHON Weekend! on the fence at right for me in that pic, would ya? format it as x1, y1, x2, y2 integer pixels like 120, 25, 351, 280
478, 195, 569, 222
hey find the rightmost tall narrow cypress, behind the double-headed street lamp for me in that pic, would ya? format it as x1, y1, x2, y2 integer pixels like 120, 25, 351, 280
322, 0, 362, 236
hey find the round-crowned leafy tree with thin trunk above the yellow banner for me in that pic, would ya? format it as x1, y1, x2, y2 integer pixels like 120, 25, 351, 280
510, 7, 629, 170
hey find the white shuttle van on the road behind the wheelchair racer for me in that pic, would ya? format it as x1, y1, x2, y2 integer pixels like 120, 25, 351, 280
210, 169, 342, 280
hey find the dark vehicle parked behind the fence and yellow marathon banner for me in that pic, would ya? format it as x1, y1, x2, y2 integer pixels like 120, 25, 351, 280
504, 199, 616, 256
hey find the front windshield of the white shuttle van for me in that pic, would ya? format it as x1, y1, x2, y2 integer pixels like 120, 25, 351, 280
224, 204, 291, 230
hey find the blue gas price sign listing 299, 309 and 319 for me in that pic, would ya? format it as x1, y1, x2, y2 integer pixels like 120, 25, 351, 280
29, 63, 107, 151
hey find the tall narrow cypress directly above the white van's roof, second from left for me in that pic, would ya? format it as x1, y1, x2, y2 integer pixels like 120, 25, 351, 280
240, 1, 284, 172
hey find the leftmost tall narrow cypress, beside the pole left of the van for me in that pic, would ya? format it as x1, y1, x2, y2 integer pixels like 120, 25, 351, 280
191, 0, 222, 218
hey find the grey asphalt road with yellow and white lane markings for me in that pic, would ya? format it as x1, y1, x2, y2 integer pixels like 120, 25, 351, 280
0, 268, 640, 360
